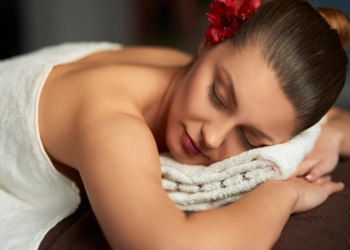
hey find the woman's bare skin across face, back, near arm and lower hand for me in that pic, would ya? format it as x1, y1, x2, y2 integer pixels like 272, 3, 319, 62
39, 40, 343, 249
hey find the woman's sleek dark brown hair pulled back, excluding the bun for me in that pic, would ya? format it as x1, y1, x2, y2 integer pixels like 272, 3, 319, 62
231, 0, 348, 135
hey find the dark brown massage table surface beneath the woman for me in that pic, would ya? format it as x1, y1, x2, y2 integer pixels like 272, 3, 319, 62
39, 159, 350, 250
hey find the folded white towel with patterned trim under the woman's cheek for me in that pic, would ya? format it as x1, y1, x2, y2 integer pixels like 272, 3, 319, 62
160, 124, 321, 211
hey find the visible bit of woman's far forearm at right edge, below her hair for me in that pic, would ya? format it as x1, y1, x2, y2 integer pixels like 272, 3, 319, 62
324, 108, 350, 157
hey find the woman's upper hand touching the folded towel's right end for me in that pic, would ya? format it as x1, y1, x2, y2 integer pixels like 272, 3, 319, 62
292, 125, 341, 182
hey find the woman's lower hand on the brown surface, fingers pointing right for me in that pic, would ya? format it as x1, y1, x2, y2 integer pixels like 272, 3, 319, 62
285, 175, 344, 213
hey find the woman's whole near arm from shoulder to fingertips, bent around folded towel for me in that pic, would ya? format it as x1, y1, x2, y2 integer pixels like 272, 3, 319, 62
66, 114, 342, 250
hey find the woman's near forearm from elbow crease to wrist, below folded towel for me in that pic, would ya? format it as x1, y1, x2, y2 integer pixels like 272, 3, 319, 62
182, 181, 297, 249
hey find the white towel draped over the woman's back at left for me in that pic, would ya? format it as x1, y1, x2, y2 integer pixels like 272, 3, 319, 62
0, 43, 120, 250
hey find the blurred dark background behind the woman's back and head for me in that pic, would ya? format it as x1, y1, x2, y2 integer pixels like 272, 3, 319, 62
0, 0, 350, 108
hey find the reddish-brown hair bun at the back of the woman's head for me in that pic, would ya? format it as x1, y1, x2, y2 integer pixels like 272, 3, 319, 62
317, 7, 350, 48
